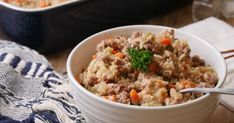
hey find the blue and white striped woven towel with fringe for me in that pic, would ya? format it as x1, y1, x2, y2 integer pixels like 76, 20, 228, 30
0, 41, 85, 123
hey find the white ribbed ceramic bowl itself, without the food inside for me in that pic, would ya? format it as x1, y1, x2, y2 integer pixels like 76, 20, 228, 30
67, 25, 226, 123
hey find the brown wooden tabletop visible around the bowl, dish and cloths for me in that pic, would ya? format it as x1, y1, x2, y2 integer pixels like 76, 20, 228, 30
0, 4, 234, 123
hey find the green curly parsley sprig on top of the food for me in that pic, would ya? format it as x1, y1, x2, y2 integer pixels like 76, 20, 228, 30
128, 48, 153, 72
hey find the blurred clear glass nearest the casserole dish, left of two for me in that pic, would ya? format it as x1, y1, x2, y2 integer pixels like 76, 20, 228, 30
192, 0, 220, 21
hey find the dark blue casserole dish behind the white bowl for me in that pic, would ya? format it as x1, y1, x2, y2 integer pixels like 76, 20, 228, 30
0, 0, 191, 52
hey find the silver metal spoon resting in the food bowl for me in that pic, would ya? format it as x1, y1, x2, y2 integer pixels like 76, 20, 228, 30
180, 88, 234, 95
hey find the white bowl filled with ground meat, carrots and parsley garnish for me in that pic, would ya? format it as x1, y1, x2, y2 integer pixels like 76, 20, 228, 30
67, 25, 226, 123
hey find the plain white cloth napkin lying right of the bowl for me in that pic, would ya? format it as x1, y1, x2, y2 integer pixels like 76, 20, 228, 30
179, 17, 234, 111
